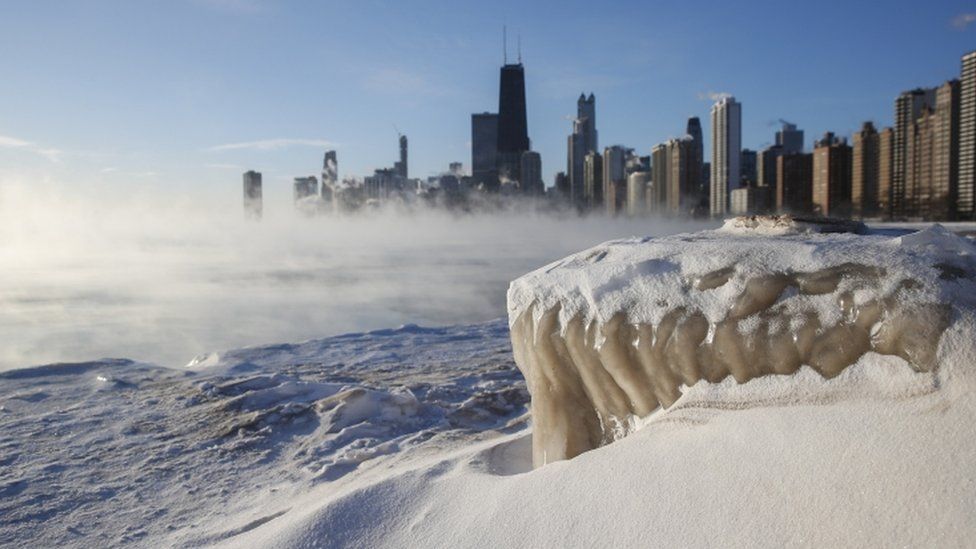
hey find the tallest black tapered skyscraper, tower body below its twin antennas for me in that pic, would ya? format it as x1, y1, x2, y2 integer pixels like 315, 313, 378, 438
497, 61, 531, 181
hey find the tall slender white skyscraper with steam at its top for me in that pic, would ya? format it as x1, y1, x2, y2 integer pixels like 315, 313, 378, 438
710, 97, 742, 217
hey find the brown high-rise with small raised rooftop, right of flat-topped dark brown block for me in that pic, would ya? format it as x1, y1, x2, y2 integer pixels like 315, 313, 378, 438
813, 132, 851, 217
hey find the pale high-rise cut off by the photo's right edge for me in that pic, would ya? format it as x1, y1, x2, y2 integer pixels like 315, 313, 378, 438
956, 51, 976, 220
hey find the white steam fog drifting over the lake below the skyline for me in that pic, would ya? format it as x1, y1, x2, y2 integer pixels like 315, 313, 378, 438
0, 185, 716, 369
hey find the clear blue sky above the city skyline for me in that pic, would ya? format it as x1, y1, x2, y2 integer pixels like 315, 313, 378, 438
0, 0, 976, 197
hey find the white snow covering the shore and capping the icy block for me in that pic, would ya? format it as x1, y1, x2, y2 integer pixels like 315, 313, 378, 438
0, 224, 976, 548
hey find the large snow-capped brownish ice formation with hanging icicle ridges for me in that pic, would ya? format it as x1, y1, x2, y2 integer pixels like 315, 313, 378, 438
508, 223, 976, 467
